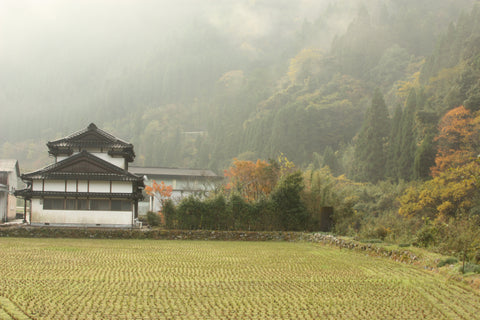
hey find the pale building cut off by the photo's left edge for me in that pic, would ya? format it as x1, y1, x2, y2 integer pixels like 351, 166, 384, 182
0, 159, 20, 222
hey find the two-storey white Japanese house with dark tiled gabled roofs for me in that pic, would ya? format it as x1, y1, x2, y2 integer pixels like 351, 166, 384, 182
16, 123, 144, 227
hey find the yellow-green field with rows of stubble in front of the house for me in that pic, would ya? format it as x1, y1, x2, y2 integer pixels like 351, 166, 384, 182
0, 238, 480, 319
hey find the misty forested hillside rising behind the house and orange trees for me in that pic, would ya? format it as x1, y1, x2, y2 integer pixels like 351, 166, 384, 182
0, 0, 480, 175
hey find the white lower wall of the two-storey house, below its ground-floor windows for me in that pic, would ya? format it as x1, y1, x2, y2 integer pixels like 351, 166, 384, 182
31, 199, 133, 226
